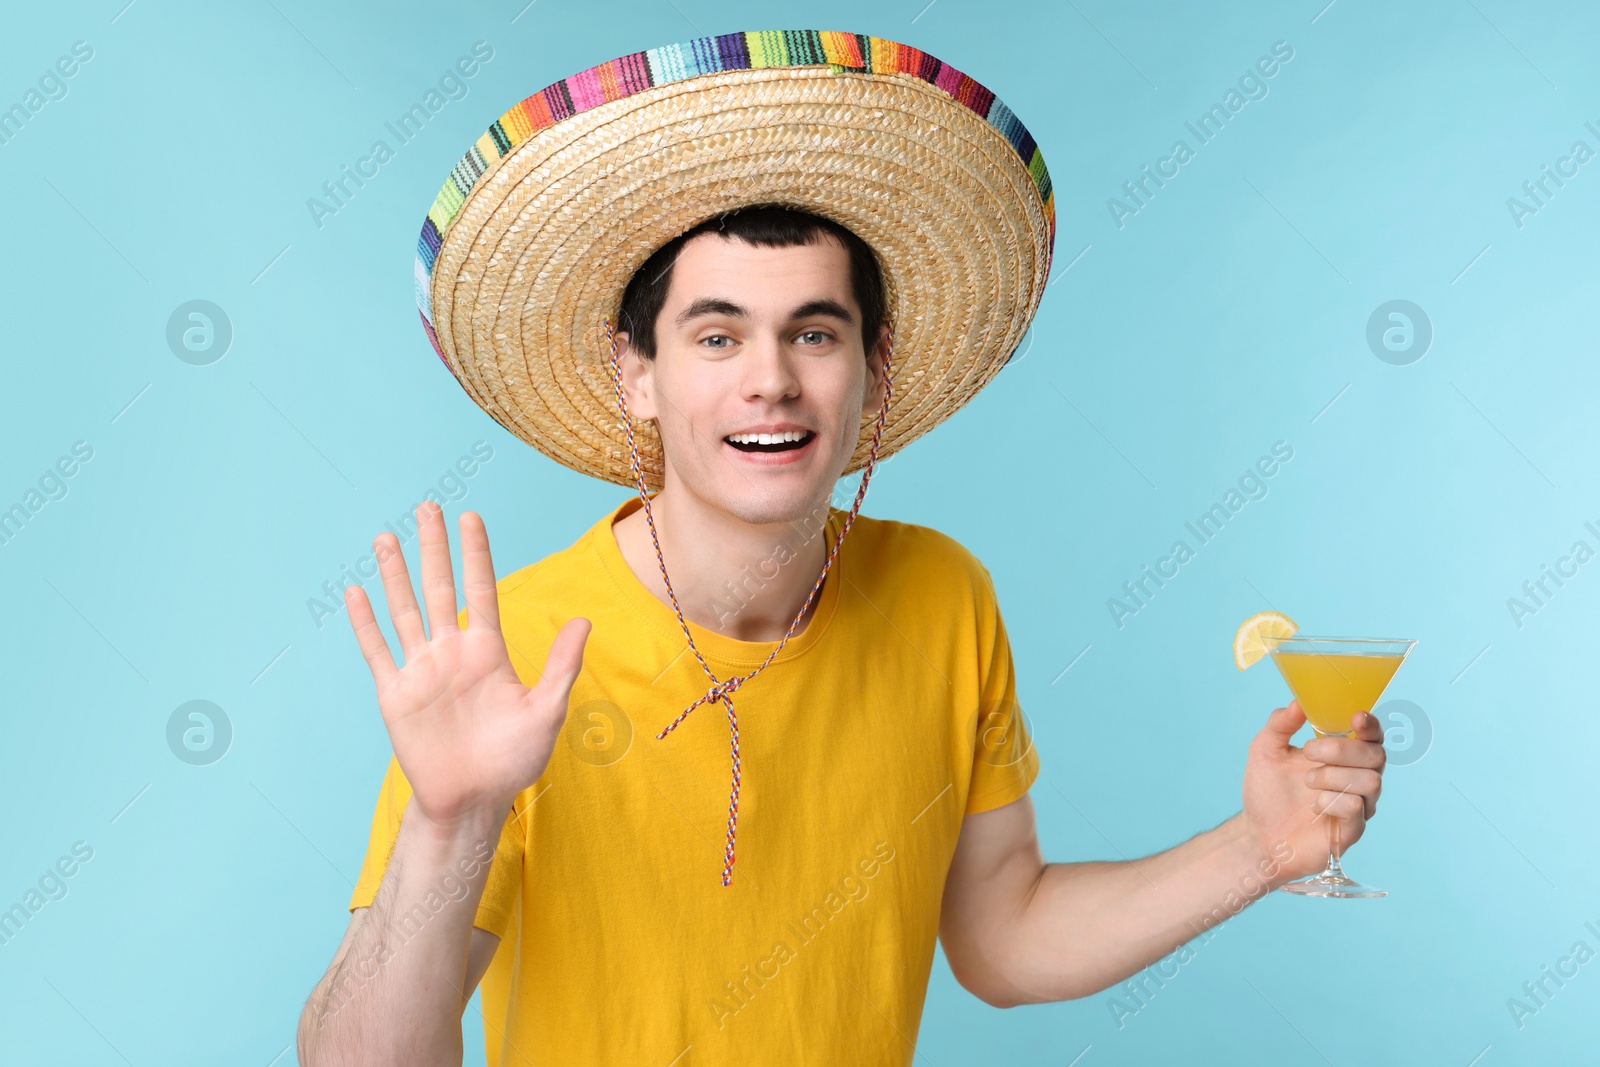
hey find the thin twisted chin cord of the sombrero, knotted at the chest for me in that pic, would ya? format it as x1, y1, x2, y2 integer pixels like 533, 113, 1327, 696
605, 320, 894, 886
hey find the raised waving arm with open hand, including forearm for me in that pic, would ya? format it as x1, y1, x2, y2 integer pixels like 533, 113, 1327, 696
298, 504, 589, 1067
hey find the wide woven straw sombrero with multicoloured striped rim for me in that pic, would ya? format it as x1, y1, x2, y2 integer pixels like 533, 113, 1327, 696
416, 30, 1056, 490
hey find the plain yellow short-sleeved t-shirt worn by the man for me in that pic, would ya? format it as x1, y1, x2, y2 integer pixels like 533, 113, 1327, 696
350, 496, 1038, 1067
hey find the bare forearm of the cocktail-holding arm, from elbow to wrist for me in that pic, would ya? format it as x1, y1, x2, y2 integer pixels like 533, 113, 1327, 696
997, 816, 1293, 1003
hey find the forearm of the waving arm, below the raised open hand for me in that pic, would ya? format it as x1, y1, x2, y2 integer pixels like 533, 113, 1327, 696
298, 809, 502, 1067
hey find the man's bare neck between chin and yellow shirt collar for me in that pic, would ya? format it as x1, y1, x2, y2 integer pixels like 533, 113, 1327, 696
611, 488, 832, 641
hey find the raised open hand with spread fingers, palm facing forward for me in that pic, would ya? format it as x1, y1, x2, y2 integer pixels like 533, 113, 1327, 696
344, 502, 590, 825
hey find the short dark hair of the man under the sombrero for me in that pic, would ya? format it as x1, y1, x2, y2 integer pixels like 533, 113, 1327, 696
618, 203, 886, 360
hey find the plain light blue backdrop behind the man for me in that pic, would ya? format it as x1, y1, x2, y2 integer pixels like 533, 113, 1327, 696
0, 0, 1600, 1067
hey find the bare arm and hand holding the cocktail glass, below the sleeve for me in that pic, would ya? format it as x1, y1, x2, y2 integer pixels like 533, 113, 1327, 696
939, 704, 1384, 1008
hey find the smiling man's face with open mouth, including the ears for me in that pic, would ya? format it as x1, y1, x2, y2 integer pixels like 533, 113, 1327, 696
622, 234, 888, 523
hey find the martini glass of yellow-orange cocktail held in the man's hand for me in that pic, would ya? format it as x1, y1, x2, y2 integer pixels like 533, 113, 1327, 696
1262, 633, 1416, 897
